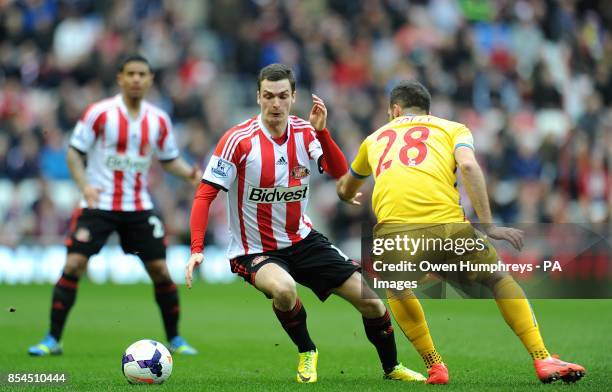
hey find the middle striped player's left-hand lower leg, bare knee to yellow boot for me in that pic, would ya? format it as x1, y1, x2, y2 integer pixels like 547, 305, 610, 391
255, 263, 319, 383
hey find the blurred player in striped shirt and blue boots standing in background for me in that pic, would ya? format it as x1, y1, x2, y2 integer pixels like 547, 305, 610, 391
29, 55, 202, 356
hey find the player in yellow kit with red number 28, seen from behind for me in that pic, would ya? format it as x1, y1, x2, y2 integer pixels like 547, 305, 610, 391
337, 81, 586, 384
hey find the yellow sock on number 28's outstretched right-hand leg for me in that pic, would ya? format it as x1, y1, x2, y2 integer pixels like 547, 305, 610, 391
493, 276, 549, 359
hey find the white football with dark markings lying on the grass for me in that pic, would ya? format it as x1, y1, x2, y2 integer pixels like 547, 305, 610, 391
121, 339, 172, 384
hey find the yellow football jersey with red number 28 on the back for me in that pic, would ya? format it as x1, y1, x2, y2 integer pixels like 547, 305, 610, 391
351, 115, 474, 224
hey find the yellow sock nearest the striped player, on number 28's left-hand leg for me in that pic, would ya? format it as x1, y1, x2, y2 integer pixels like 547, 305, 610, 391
389, 293, 442, 368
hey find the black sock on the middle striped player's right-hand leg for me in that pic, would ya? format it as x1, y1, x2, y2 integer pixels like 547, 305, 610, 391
363, 311, 398, 373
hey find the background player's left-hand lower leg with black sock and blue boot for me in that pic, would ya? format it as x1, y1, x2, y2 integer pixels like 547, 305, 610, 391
28, 253, 89, 356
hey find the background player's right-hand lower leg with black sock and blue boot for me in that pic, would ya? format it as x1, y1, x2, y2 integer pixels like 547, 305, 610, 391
144, 259, 198, 355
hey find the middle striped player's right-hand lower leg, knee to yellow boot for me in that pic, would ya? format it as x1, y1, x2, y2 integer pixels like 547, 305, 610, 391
333, 272, 425, 381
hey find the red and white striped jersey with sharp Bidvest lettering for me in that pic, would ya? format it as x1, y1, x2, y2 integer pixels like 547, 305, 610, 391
203, 116, 323, 259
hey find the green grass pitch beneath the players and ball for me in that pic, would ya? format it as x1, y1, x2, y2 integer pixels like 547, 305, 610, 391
0, 281, 612, 391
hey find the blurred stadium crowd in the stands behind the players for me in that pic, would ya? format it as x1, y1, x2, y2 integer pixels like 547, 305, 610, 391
0, 0, 612, 250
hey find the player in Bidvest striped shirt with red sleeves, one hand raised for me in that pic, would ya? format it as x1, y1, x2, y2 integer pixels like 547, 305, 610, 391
186, 64, 425, 383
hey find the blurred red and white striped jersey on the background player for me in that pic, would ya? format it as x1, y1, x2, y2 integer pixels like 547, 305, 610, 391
70, 95, 179, 211
